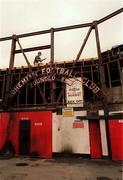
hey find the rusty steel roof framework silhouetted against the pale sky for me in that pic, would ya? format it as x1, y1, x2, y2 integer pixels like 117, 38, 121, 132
0, 8, 123, 109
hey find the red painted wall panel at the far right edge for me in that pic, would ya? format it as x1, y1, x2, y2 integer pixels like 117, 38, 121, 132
109, 119, 123, 160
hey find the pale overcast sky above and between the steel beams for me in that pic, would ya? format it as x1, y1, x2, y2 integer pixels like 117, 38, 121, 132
0, 0, 123, 68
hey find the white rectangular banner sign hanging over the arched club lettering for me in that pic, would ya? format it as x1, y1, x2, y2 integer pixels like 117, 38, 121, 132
66, 78, 83, 107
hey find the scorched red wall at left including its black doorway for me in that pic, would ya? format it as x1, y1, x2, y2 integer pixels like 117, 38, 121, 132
0, 111, 52, 158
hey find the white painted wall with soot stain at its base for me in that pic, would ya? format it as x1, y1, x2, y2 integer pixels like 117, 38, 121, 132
52, 111, 90, 154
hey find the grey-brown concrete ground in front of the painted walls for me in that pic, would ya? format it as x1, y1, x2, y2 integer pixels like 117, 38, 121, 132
0, 157, 123, 180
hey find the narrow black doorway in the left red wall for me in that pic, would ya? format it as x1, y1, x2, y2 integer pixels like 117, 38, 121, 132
19, 120, 30, 155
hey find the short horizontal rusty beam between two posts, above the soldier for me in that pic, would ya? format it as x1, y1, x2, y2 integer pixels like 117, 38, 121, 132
15, 45, 51, 54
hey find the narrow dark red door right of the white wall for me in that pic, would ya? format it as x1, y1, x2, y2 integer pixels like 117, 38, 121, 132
89, 119, 102, 159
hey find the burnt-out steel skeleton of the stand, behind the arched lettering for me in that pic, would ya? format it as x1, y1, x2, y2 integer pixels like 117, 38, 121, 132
0, 8, 123, 109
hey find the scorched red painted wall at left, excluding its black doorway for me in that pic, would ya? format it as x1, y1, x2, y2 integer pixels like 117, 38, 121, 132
0, 111, 52, 158
